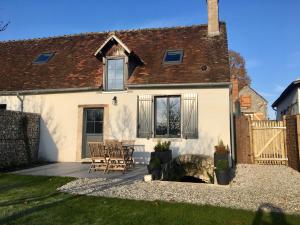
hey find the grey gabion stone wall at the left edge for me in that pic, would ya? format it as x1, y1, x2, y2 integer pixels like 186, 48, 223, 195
0, 110, 40, 169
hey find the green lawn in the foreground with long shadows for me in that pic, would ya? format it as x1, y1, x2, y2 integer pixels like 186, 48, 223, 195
0, 174, 300, 225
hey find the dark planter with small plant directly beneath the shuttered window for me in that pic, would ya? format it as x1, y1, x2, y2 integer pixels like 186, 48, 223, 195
151, 141, 172, 164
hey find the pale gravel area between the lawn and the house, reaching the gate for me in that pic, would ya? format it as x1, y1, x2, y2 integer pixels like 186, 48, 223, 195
58, 165, 300, 214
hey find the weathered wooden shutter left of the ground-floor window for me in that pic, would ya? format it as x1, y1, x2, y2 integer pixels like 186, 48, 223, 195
137, 95, 153, 138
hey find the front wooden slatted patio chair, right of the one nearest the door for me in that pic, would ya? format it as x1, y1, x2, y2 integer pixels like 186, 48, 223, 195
106, 142, 127, 173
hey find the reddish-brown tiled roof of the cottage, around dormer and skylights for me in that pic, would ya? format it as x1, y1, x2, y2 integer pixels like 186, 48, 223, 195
0, 23, 229, 91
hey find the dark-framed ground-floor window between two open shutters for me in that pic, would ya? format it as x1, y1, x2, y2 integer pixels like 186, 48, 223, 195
155, 96, 181, 137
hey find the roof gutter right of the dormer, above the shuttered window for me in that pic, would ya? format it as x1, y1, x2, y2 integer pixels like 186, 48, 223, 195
127, 82, 230, 88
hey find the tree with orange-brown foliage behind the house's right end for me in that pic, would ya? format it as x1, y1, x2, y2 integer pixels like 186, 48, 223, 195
229, 50, 251, 88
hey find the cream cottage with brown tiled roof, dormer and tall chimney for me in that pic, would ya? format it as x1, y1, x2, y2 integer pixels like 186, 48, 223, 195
0, 0, 232, 162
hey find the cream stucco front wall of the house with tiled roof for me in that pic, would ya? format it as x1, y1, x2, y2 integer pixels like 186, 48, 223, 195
0, 88, 230, 162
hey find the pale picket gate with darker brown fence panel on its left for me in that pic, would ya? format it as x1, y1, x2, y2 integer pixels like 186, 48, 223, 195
235, 116, 288, 165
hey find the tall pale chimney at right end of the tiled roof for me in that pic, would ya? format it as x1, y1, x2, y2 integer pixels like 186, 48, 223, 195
206, 0, 220, 37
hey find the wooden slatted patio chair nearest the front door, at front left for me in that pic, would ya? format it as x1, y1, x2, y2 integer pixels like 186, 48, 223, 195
88, 142, 108, 173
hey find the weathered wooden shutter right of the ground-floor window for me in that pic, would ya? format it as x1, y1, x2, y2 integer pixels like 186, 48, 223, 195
182, 94, 198, 138
